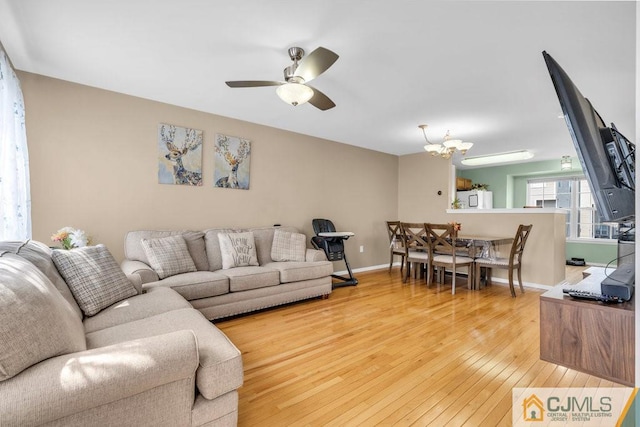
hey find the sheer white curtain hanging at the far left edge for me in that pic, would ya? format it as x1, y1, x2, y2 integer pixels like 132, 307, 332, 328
0, 45, 31, 240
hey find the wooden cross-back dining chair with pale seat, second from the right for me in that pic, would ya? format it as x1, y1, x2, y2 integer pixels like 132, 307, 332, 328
424, 223, 474, 295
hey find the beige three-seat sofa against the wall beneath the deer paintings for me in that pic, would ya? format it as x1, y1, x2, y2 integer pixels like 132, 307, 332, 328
121, 226, 333, 320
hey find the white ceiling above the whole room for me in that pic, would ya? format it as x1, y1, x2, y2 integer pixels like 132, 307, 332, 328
0, 0, 636, 168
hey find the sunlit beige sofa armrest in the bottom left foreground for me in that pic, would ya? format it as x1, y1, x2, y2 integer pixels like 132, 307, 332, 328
0, 330, 199, 425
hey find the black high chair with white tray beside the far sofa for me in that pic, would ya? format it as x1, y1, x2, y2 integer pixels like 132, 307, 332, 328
311, 218, 358, 288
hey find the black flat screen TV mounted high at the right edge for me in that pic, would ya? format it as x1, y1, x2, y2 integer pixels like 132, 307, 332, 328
542, 52, 635, 222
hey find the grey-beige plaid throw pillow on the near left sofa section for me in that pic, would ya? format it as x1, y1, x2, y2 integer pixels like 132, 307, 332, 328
52, 245, 138, 316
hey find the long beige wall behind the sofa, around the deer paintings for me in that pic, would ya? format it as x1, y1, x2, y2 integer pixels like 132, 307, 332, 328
19, 72, 398, 270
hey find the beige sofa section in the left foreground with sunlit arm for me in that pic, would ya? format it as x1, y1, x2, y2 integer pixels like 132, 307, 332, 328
0, 241, 243, 427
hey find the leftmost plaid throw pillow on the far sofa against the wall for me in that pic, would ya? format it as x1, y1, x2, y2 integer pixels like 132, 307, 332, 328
142, 234, 197, 279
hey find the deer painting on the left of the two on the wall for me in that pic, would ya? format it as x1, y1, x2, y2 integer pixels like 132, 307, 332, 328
158, 123, 202, 185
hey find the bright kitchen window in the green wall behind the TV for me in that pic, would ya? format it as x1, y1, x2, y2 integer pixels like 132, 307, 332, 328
527, 176, 618, 239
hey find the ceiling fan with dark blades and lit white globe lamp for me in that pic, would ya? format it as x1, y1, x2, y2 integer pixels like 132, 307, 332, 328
226, 47, 338, 111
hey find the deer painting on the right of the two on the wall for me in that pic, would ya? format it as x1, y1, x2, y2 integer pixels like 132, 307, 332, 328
218, 134, 251, 190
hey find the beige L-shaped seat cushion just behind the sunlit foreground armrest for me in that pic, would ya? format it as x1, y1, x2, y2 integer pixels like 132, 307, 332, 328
87, 308, 243, 399
